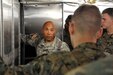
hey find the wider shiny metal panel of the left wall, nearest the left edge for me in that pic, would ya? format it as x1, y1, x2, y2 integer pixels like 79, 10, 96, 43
3, 0, 13, 64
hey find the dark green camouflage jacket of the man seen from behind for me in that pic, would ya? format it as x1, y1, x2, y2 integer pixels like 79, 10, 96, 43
0, 43, 105, 75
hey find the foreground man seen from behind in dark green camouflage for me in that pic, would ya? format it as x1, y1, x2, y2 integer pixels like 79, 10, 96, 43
0, 5, 105, 75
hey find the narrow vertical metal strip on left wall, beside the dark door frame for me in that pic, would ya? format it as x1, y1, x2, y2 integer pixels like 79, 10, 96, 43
12, 0, 21, 65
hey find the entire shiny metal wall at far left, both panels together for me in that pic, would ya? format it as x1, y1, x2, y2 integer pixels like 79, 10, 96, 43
0, 0, 19, 65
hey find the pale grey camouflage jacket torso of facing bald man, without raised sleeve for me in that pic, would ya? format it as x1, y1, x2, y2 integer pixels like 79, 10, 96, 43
36, 37, 70, 56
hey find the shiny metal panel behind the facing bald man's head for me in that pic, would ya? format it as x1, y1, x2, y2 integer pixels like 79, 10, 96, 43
24, 4, 62, 37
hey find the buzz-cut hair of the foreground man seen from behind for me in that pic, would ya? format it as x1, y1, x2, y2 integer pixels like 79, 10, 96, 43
72, 4, 101, 35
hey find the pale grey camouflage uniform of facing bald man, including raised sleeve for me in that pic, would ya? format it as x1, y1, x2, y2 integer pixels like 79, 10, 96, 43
22, 34, 70, 56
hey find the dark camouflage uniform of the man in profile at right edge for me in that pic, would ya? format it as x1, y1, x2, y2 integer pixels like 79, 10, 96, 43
97, 32, 113, 55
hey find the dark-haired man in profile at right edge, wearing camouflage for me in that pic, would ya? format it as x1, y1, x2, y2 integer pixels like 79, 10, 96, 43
98, 8, 113, 55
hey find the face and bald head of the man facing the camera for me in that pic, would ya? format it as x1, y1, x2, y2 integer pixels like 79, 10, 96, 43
43, 23, 56, 42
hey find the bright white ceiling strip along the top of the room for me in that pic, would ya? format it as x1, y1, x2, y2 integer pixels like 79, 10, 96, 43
20, 0, 113, 4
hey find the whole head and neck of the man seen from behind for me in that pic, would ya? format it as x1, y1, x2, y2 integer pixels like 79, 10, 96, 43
69, 5, 102, 48
